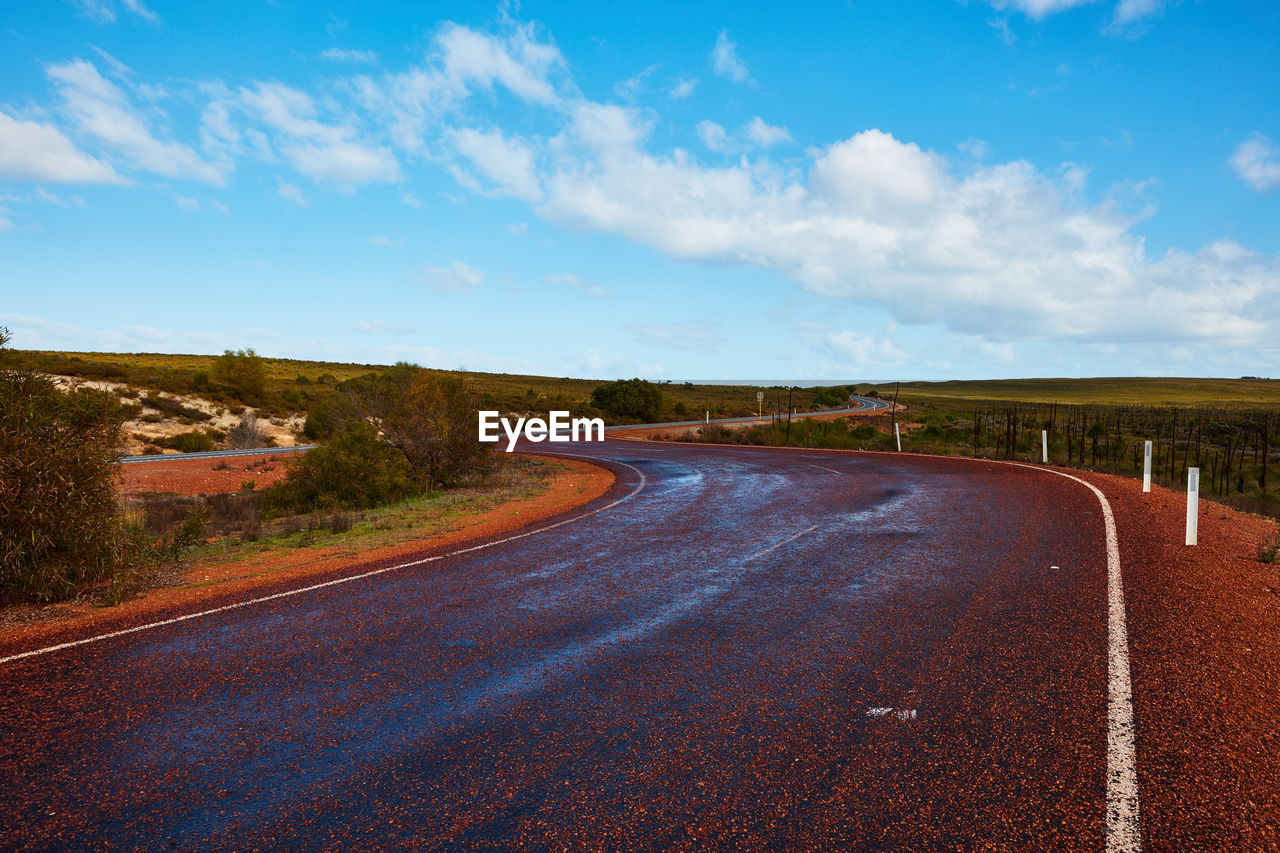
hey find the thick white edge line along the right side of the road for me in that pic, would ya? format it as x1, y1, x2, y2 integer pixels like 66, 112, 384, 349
1011, 462, 1142, 853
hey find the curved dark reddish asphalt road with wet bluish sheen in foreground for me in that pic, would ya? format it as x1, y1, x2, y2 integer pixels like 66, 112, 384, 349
0, 441, 1131, 850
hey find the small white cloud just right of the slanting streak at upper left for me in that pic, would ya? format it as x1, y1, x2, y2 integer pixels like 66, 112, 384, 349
238, 83, 401, 191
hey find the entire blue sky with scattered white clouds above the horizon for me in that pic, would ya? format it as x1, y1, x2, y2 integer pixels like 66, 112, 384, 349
0, 0, 1280, 380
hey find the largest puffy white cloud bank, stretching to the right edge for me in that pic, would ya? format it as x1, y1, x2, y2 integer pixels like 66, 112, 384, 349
541, 121, 1280, 346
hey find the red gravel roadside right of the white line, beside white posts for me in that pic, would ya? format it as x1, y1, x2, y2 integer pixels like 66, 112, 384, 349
1074, 471, 1280, 850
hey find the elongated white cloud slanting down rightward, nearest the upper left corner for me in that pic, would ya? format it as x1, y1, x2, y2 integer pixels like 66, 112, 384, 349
45, 59, 223, 186
